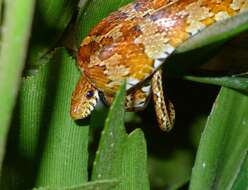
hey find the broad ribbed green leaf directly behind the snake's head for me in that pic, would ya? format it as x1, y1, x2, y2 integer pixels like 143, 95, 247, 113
31, 49, 89, 187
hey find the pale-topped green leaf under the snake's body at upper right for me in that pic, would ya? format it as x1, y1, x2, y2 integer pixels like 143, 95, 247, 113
176, 11, 248, 53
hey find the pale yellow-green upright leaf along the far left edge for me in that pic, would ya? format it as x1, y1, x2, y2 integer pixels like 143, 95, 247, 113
0, 0, 34, 173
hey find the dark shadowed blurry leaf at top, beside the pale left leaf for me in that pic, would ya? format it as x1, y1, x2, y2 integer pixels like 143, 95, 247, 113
28, 0, 79, 66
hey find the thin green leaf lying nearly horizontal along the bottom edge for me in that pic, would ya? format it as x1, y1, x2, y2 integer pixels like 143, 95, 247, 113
33, 180, 119, 190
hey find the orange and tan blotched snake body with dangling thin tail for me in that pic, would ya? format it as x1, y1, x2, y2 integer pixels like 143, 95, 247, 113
71, 0, 248, 130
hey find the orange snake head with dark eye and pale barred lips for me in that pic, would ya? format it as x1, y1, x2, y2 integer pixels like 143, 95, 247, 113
71, 76, 99, 120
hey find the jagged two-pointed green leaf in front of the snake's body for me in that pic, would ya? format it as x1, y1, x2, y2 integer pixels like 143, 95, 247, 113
92, 85, 149, 190
